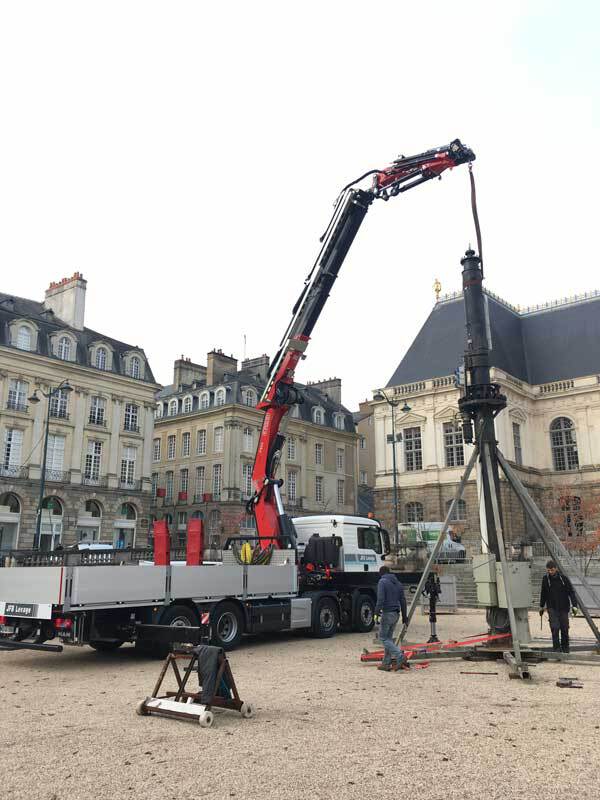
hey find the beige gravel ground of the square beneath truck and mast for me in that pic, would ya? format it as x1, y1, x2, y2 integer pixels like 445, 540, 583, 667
0, 612, 600, 800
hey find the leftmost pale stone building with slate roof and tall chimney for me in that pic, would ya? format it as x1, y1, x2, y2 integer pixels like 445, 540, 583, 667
0, 273, 158, 550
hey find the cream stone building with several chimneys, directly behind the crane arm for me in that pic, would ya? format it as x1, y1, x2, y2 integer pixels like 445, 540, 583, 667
152, 351, 357, 549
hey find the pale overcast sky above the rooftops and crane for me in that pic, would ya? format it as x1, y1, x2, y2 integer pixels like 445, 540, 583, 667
0, 0, 600, 408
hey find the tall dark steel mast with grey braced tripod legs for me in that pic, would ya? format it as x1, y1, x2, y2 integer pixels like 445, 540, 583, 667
397, 250, 600, 677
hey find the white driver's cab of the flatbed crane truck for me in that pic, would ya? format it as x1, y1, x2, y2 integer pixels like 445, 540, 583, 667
292, 514, 390, 572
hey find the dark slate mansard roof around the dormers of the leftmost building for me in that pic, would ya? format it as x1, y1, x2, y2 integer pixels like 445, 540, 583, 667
0, 292, 156, 383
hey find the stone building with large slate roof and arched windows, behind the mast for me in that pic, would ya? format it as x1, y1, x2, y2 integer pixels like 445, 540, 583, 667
371, 292, 600, 551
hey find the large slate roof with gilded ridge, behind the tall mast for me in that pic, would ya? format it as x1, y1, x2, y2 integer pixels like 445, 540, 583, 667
387, 292, 600, 386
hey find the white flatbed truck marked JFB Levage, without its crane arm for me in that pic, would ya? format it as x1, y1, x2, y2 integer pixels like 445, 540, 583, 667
0, 515, 408, 650
